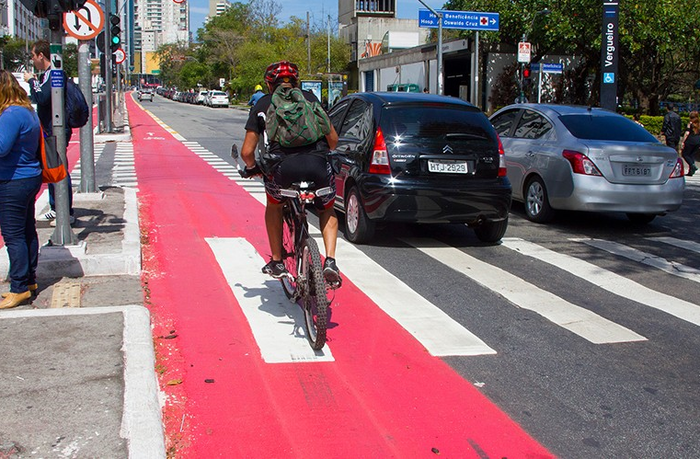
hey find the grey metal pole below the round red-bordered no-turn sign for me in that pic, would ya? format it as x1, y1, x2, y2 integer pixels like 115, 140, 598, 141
78, 40, 97, 193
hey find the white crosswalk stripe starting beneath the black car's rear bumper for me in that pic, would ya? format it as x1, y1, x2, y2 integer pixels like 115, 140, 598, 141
402, 239, 646, 344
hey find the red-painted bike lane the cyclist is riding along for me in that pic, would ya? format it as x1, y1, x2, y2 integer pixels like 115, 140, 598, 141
127, 97, 551, 458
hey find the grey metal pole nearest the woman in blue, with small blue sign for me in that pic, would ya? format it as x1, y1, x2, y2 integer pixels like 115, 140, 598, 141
49, 27, 77, 246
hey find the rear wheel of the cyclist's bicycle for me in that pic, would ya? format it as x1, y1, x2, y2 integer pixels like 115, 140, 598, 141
301, 238, 328, 351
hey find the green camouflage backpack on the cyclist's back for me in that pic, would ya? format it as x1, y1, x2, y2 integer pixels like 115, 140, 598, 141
265, 86, 331, 147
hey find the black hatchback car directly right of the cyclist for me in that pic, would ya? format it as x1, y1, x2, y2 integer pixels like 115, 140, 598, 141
330, 92, 511, 243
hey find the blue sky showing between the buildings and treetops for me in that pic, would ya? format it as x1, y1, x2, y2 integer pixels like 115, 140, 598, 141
189, 0, 432, 39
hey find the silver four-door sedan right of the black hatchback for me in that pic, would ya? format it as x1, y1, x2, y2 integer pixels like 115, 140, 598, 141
490, 104, 685, 223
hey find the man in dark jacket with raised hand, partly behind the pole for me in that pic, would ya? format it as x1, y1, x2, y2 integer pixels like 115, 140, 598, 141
24, 40, 75, 224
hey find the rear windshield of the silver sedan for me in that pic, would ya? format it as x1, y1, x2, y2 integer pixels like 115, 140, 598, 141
559, 114, 657, 142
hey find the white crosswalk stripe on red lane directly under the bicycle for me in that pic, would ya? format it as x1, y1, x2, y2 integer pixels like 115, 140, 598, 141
206, 238, 334, 363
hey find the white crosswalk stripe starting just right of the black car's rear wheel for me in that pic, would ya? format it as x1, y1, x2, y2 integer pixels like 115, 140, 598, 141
503, 238, 700, 325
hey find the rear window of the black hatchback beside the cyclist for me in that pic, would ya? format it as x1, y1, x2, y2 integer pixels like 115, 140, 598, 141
380, 104, 495, 140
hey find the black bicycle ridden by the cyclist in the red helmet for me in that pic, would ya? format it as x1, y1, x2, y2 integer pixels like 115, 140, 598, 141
231, 145, 333, 350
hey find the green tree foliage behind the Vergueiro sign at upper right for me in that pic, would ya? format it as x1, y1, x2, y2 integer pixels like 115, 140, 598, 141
445, 0, 700, 114
